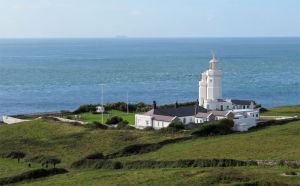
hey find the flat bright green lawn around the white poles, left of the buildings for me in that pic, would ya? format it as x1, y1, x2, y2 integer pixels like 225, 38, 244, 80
65, 110, 136, 125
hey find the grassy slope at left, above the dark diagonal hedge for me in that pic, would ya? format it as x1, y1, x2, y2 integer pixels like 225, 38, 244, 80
0, 120, 183, 166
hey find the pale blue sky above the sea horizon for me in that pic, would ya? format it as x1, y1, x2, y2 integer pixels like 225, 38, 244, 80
0, 0, 300, 38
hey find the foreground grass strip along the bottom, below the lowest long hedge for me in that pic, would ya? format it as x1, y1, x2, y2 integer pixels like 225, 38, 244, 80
18, 167, 300, 186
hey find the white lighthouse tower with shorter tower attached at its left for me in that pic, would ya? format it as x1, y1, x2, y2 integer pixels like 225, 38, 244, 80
199, 52, 223, 110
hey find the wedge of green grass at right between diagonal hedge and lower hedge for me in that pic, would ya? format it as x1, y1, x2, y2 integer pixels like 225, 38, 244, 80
121, 121, 300, 160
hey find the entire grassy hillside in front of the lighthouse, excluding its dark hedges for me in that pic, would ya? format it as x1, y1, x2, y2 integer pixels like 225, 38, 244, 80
0, 108, 300, 185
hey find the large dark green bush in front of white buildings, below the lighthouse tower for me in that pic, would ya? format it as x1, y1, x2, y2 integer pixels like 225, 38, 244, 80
192, 119, 234, 136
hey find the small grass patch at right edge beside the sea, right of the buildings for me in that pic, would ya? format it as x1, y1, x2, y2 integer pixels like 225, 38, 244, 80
262, 105, 300, 116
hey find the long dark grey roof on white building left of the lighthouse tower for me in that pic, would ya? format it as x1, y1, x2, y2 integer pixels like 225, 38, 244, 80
145, 106, 207, 117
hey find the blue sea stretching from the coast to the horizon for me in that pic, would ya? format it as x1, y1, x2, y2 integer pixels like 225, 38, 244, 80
0, 38, 300, 116
